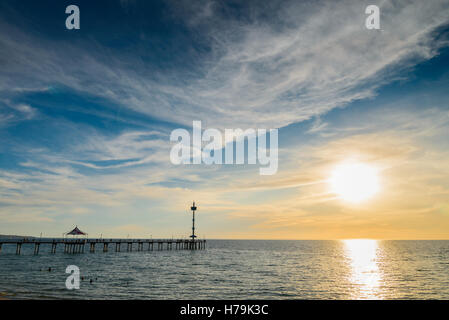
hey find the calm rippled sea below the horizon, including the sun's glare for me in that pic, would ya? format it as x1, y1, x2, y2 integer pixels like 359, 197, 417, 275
0, 240, 449, 299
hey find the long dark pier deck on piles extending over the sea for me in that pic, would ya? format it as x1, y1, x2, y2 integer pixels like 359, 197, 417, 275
0, 238, 206, 255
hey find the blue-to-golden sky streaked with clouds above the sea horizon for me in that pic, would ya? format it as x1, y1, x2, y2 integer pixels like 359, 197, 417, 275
0, 0, 449, 239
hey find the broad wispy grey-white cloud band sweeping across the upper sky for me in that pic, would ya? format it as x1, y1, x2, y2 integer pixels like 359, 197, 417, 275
0, 1, 449, 127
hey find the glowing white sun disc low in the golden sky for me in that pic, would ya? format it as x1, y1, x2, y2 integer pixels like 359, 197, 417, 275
329, 162, 379, 203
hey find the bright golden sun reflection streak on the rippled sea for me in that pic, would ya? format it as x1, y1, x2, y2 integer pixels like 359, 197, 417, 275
343, 239, 381, 299
